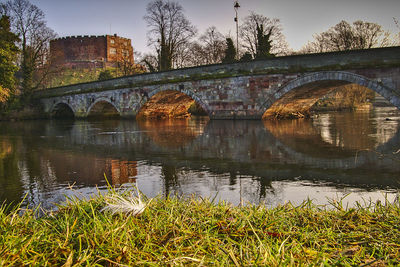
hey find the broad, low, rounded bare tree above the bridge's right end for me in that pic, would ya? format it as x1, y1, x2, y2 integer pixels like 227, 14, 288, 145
301, 20, 393, 53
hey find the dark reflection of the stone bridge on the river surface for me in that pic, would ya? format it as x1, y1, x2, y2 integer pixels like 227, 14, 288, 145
33, 116, 400, 188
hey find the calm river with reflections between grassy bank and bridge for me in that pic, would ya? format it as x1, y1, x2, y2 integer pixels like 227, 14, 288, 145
0, 107, 400, 209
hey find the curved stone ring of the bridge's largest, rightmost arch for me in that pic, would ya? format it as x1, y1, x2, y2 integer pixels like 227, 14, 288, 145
261, 71, 400, 117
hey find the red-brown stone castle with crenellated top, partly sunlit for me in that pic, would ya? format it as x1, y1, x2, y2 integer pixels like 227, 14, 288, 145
50, 34, 134, 68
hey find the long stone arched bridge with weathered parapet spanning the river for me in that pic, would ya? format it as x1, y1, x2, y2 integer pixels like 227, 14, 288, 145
34, 47, 400, 119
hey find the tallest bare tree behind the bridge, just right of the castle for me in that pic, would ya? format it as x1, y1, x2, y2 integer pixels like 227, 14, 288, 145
144, 0, 197, 70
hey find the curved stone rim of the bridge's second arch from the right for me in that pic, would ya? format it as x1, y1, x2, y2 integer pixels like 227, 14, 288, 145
136, 87, 210, 118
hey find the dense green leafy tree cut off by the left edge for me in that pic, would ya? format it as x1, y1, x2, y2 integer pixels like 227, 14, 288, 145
0, 16, 19, 102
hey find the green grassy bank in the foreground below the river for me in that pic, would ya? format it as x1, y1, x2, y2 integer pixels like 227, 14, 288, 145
0, 189, 400, 266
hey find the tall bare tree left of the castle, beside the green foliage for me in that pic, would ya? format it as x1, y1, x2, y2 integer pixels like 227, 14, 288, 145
6, 0, 56, 95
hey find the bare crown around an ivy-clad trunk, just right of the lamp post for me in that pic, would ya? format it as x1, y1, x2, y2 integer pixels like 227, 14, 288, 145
240, 12, 289, 58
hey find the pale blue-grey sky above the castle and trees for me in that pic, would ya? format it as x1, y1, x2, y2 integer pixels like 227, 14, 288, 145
30, 0, 400, 53
